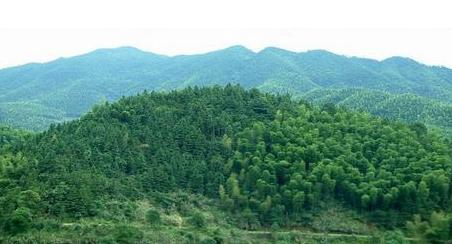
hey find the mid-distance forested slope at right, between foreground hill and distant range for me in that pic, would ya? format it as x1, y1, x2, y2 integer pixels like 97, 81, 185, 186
302, 89, 452, 138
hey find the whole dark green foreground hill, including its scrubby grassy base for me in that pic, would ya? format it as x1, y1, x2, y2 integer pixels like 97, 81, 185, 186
0, 85, 452, 243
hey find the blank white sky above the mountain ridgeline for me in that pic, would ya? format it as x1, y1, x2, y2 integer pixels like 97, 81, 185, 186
0, 0, 452, 68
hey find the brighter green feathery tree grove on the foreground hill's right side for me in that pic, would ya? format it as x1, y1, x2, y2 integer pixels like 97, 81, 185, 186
220, 100, 452, 225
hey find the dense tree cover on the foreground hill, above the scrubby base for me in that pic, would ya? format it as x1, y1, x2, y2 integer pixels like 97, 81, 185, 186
0, 86, 452, 241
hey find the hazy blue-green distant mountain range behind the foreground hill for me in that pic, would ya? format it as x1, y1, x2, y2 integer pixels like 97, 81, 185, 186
0, 46, 452, 133
